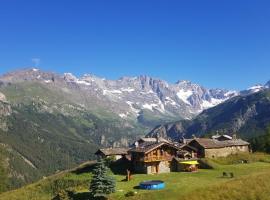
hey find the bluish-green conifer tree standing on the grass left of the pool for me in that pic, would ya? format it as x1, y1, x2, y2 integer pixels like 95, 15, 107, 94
90, 160, 115, 199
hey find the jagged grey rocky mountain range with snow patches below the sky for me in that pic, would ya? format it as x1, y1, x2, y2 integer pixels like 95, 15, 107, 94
0, 68, 239, 122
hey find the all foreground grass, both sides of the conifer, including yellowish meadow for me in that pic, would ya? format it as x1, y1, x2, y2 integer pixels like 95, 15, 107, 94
0, 156, 270, 200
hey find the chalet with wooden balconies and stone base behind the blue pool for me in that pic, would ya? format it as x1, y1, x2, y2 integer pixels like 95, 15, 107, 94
128, 138, 196, 174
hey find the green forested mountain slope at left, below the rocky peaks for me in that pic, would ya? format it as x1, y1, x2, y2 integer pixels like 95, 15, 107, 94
0, 82, 145, 188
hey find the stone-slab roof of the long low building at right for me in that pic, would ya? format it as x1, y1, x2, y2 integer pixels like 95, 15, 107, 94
189, 138, 249, 149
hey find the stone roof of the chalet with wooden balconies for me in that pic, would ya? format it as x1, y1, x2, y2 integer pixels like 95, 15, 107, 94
128, 142, 179, 153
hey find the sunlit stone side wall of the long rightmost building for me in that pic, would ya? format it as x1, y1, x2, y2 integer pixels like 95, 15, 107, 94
205, 146, 249, 158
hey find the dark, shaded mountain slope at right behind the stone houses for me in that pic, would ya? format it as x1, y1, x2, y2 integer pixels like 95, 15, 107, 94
148, 89, 270, 140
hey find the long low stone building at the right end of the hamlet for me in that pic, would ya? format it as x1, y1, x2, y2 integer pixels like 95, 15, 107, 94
188, 135, 250, 158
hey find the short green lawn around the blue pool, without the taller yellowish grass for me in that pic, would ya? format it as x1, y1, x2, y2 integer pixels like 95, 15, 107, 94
109, 162, 270, 200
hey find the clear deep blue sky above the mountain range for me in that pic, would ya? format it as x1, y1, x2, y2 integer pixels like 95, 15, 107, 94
0, 0, 270, 89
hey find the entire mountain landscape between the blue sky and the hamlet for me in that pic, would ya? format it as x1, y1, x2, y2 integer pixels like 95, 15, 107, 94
0, 68, 270, 189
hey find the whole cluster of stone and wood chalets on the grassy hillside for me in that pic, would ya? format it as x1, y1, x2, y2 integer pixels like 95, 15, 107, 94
96, 135, 250, 174
